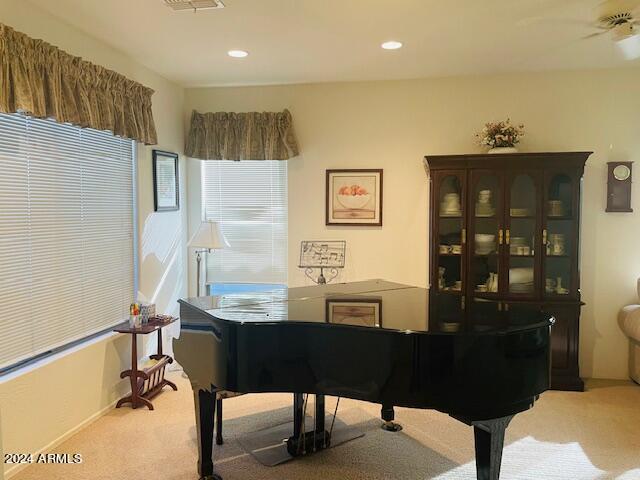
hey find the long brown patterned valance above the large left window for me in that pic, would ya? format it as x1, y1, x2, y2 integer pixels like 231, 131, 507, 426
0, 24, 157, 145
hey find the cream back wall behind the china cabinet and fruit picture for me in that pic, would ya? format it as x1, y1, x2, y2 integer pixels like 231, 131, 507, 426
185, 68, 640, 378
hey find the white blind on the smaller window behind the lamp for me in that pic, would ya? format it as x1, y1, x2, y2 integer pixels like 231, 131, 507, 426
202, 160, 287, 284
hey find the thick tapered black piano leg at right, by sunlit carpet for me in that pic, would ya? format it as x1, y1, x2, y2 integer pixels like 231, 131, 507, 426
472, 415, 513, 480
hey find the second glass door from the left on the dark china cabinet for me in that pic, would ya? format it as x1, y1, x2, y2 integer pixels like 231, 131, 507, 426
468, 170, 503, 298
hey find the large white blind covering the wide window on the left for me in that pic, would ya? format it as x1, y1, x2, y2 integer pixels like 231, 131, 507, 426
0, 114, 135, 369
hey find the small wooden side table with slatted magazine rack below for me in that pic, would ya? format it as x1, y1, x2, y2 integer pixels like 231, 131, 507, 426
113, 316, 178, 410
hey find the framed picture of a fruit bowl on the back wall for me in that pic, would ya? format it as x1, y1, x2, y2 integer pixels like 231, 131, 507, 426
326, 169, 382, 226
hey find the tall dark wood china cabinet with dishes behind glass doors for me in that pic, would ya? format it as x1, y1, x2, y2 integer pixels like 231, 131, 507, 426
425, 152, 591, 391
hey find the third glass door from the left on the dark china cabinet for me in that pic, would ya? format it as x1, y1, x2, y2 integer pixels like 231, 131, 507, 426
505, 172, 540, 298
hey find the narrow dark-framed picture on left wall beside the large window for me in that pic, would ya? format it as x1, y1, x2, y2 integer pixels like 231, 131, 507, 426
153, 150, 180, 212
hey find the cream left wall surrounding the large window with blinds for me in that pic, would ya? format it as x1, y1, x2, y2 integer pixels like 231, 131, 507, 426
0, 0, 187, 473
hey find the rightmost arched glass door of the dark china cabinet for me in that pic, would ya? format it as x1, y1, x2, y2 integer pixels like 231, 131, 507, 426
543, 172, 578, 298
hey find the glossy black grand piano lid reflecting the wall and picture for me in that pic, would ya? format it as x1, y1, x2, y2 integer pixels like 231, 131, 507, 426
180, 280, 553, 335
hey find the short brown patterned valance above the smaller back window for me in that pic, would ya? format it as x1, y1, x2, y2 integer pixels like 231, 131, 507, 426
185, 110, 298, 160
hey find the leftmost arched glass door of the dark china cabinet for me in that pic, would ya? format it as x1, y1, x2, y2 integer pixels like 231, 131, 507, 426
434, 172, 466, 295
